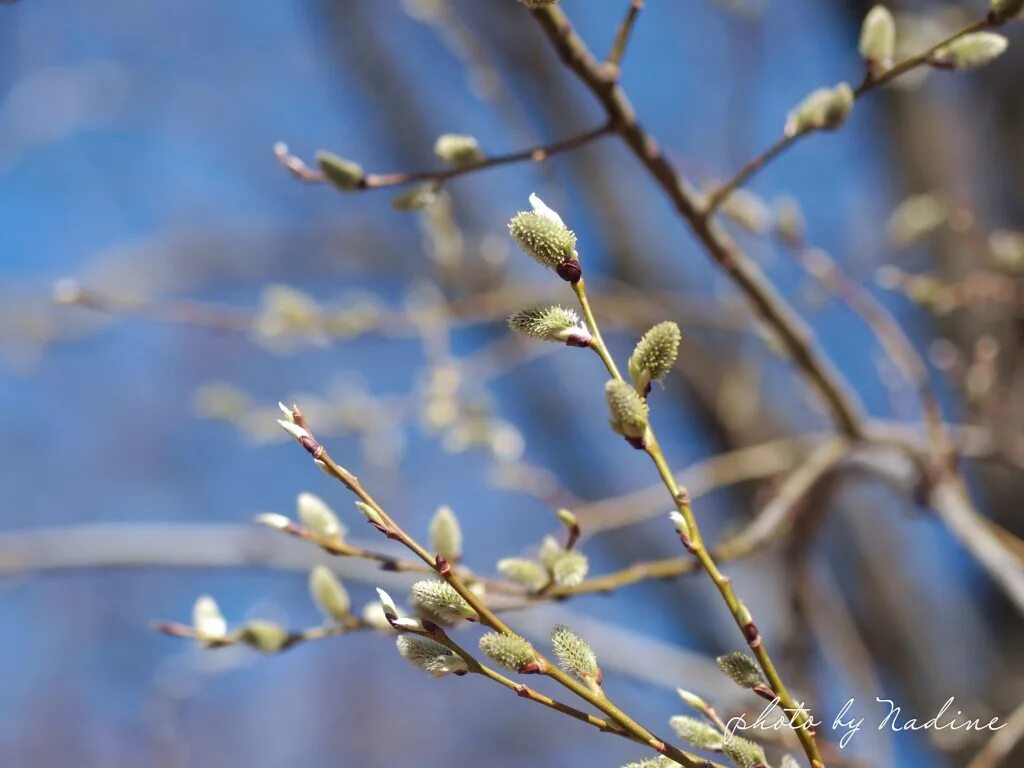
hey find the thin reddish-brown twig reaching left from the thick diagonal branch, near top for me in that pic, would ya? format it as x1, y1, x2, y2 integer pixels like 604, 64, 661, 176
274, 123, 612, 190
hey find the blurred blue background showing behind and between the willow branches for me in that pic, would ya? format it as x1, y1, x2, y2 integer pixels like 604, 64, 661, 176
0, 0, 1020, 768
